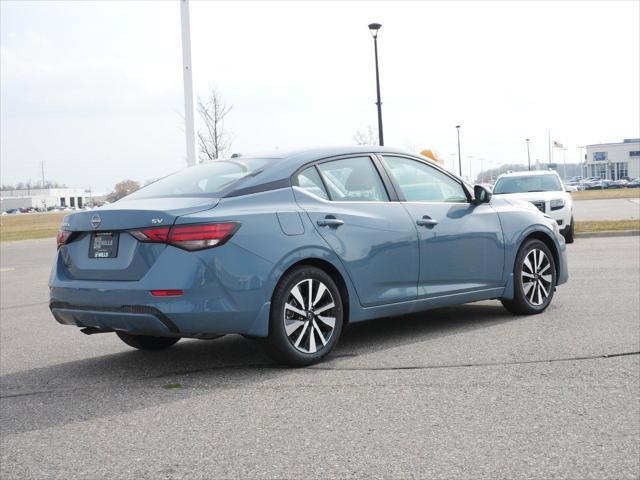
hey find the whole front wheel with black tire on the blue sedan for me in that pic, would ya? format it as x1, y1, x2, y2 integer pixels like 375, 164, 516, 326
501, 240, 556, 315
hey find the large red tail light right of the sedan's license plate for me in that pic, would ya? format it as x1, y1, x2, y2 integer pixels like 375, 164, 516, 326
129, 222, 240, 251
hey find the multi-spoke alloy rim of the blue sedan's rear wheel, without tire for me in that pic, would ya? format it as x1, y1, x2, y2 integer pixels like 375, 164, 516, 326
283, 278, 336, 353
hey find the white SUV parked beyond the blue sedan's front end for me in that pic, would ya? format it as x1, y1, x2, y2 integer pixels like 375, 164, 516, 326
493, 170, 574, 243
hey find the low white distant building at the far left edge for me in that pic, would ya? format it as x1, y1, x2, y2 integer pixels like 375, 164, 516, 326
0, 188, 89, 211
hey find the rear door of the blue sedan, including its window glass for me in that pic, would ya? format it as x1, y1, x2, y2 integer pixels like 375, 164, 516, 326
293, 155, 419, 306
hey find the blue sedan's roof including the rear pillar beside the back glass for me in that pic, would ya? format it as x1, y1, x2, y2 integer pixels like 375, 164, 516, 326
224, 145, 435, 196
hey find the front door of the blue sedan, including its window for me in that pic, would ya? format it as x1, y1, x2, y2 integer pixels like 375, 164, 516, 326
381, 155, 504, 297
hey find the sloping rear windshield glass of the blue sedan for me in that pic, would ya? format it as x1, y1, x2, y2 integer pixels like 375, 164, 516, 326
125, 158, 269, 200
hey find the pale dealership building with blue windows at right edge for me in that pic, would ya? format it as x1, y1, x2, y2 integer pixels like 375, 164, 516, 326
585, 138, 640, 180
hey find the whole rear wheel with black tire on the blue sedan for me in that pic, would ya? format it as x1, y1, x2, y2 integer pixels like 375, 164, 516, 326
267, 266, 344, 366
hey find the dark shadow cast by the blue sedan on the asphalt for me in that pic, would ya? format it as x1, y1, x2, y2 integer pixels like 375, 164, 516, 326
0, 302, 523, 435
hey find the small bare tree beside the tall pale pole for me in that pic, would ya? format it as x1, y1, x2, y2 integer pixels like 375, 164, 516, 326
198, 86, 232, 162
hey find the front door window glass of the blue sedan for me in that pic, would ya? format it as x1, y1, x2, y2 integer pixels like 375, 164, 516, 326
383, 156, 467, 203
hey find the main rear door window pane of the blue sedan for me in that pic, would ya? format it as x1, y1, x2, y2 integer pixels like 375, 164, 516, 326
318, 157, 389, 202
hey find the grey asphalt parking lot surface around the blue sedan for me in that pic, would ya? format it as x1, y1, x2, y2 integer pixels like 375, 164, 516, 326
0, 237, 640, 479
